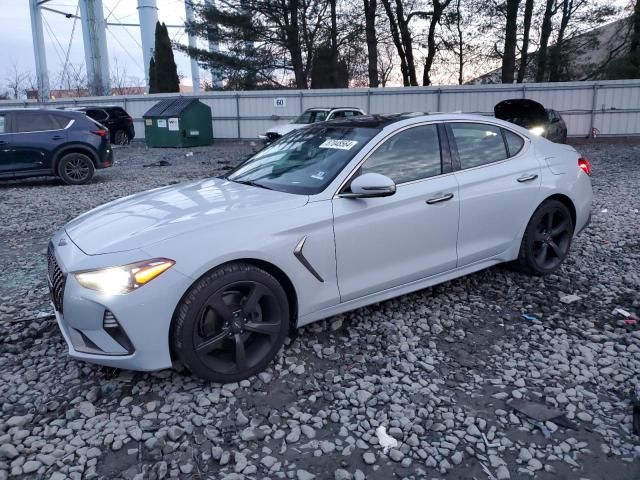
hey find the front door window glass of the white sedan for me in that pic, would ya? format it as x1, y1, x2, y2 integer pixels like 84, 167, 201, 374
360, 125, 442, 184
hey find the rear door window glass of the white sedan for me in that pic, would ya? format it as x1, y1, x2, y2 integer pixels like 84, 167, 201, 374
450, 123, 508, 170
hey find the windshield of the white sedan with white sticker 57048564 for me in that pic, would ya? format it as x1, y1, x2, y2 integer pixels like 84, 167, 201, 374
226, 124, 379, 195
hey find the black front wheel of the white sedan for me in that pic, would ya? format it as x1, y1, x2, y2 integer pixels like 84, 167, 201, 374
171, 263, 289, 383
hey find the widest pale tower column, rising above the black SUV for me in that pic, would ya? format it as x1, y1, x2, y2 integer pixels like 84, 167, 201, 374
80, 0, 111, 96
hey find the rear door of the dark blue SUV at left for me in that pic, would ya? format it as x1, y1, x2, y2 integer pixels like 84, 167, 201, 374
9, 111, 69, 173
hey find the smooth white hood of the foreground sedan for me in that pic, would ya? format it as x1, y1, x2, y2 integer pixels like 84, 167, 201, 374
65, 178, 308, 255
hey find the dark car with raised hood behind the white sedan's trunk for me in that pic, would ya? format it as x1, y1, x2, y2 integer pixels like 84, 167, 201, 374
493, 98, 567, 143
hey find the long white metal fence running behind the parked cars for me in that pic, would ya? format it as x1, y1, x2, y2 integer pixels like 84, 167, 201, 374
0, 80, 640, 139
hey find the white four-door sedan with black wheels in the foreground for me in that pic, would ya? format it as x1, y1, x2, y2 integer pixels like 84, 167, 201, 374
49, 114, 592, 382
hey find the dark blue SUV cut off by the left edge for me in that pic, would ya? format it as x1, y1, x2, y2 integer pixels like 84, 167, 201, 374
0, 109, 113, 185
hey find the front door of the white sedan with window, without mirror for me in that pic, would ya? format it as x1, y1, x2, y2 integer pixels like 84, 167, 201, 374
333, 124, 459, 302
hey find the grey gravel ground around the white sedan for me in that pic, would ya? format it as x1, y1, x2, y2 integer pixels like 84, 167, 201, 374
0, 143, 640, 480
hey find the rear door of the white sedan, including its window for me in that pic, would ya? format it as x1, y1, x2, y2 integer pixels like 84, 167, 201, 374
447, 122, 540, 267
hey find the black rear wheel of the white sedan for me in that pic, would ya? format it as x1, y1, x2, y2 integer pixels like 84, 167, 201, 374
518, 200, 574, 275
